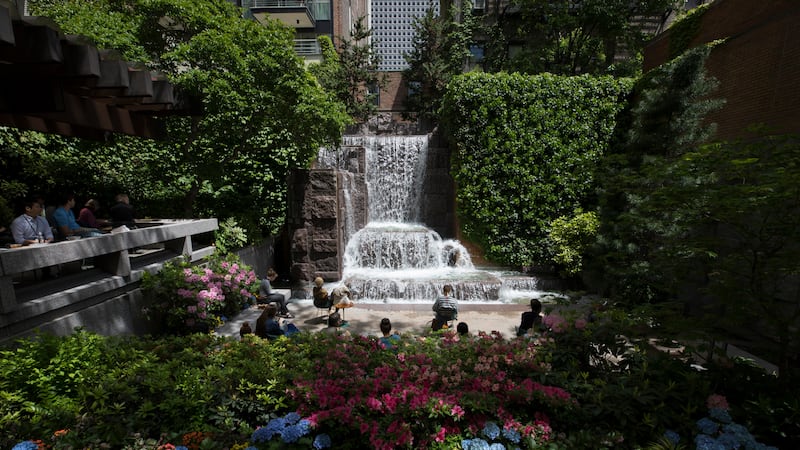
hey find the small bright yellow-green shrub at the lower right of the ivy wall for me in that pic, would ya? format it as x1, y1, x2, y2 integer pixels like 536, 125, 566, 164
549, 211, 600, 276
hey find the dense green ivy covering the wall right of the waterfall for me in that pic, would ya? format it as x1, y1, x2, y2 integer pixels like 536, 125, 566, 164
443, 73, 631, 266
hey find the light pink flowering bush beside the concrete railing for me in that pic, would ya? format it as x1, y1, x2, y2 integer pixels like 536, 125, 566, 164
142, 255, 258, 333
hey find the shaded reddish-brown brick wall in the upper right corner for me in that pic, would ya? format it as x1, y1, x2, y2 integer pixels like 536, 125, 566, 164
644, 0, 800, 139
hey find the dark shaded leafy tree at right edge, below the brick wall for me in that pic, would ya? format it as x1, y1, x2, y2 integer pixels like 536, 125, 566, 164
670, 136, 800, 379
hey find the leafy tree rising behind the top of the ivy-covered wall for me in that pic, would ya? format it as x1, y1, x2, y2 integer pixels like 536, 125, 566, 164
505, 0, 682, 75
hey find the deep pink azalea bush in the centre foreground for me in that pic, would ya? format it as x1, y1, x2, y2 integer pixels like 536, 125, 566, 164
264, 333, 577, 449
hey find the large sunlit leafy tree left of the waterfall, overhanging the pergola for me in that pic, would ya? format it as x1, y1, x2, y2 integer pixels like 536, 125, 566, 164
22, 0, 348, 236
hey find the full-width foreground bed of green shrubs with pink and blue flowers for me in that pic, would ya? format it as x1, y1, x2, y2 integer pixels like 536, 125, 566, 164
0, 314, 798, 450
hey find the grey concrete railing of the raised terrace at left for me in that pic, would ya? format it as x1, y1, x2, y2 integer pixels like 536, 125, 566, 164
0, 219, 218, 340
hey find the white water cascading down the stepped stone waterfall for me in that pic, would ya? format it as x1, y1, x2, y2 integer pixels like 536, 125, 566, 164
319, 136, 552, 302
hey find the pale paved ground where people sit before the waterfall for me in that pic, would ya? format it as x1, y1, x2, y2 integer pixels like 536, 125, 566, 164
217, 290, 529, 337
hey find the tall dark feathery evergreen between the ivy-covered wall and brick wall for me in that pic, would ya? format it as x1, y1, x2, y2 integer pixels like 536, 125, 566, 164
595, 46, 722, 304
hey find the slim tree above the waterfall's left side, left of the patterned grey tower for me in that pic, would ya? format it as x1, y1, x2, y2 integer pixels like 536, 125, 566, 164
310, 17, 386, 122
